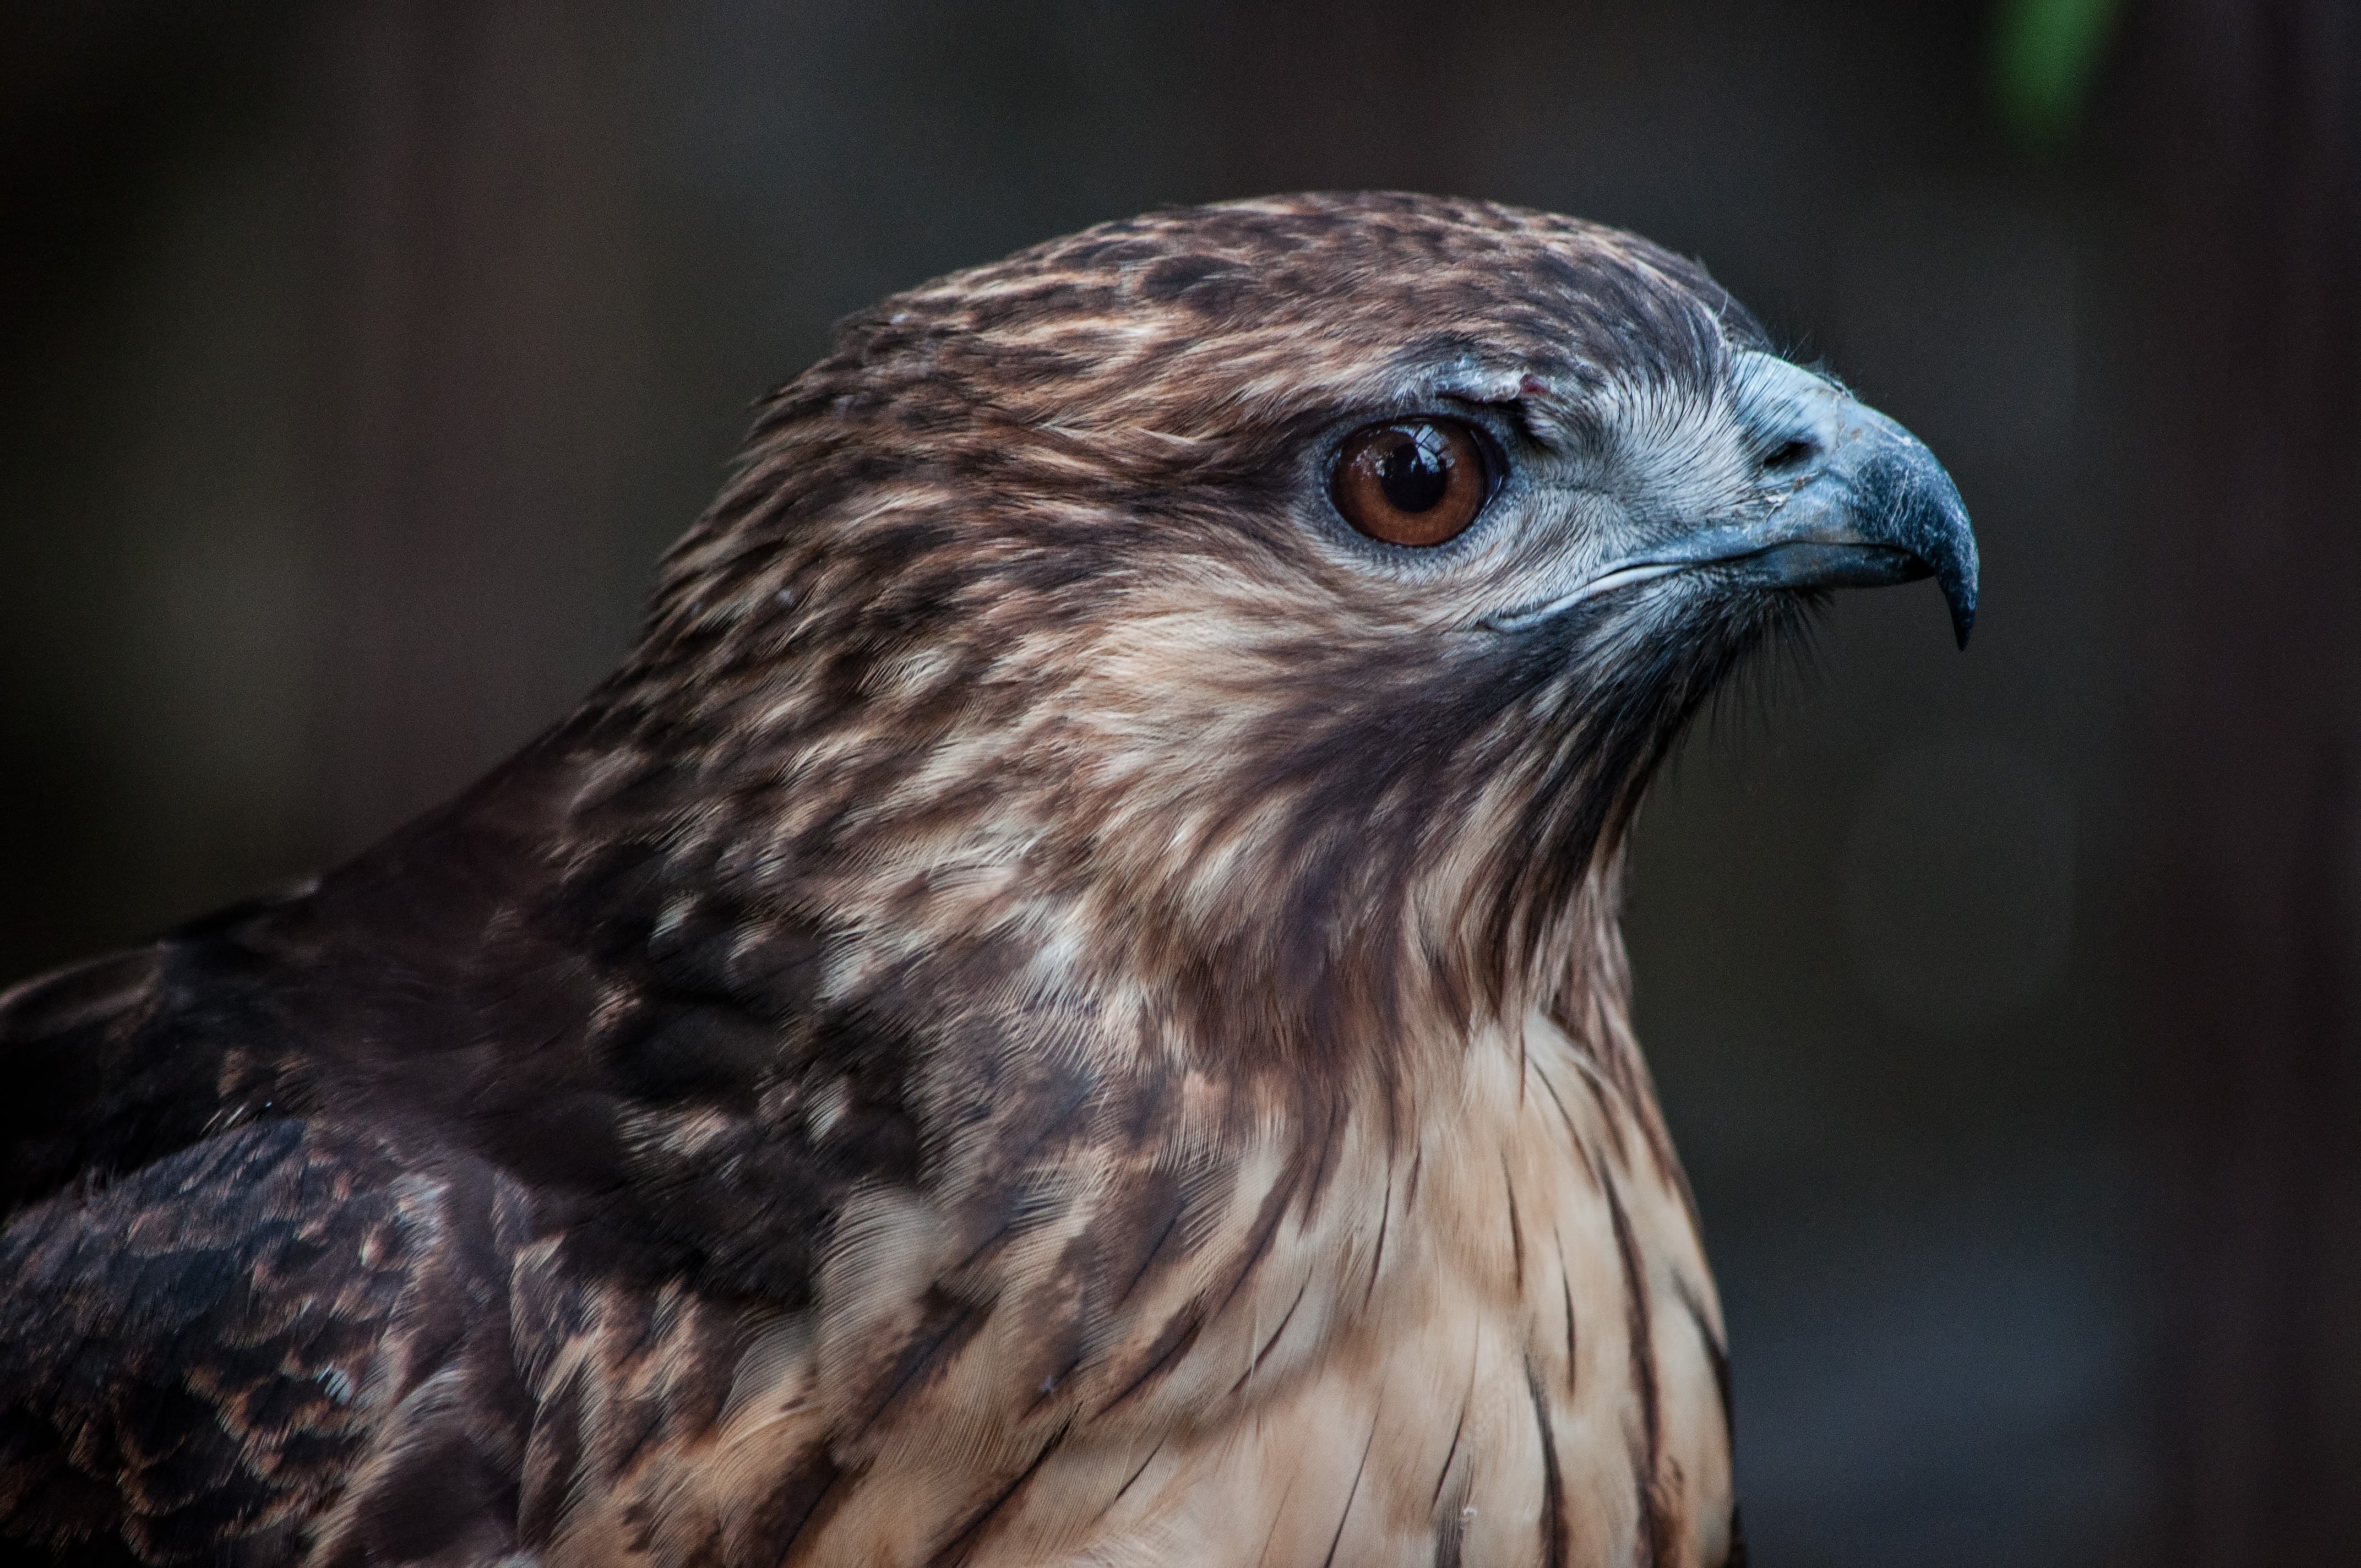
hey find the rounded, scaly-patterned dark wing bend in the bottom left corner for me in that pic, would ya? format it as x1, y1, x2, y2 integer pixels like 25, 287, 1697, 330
0, 1119, 425, 1566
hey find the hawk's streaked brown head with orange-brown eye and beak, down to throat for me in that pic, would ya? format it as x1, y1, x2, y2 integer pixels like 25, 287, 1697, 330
580, 194, 1976, 1096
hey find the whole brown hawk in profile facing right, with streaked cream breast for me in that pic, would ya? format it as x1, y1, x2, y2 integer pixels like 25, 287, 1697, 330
0, 196, 1976, 1568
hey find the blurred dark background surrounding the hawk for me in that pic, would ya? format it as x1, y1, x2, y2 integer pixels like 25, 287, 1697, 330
0, 0, 2361, 1568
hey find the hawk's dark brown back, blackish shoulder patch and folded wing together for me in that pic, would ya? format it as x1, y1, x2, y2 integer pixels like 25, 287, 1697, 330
0, 737, 939, 1568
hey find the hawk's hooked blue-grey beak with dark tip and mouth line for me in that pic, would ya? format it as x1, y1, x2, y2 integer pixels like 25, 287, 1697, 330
1494, 352, 1976, 647
